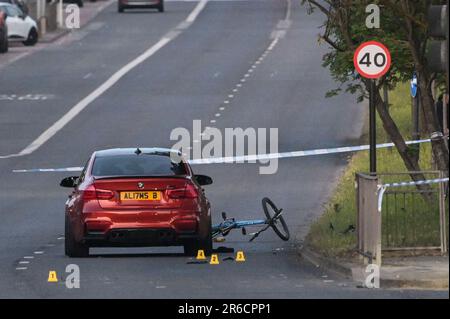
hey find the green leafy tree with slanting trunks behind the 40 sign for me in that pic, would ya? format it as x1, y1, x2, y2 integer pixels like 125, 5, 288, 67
302, 0, 448, 178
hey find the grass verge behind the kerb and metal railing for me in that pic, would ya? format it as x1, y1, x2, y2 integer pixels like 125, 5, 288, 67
306, 84, 446, 257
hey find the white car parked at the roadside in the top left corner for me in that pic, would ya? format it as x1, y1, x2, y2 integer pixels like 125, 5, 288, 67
0, 2, 39, 46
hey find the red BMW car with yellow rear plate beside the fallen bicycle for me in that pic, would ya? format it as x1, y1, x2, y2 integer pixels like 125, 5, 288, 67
60, 148, 212, 257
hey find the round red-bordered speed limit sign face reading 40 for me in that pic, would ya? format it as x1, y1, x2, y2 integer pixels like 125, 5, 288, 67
353, 41, 391, 79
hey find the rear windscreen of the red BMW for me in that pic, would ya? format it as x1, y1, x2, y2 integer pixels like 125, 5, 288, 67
92, 154, 187, 177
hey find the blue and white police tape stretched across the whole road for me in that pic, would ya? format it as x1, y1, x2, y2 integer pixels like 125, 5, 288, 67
13, 139, 431, 173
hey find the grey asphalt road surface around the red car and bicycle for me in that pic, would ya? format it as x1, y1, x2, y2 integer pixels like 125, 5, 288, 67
0, 0, 448, 299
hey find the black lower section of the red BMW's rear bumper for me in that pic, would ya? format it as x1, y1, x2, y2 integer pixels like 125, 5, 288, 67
83, 228, 198, 247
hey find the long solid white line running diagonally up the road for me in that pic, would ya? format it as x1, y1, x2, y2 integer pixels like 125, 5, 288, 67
0, 0, 208, 159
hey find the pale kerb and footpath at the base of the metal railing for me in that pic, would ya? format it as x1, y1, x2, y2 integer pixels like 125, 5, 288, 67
300, 246, 449, 291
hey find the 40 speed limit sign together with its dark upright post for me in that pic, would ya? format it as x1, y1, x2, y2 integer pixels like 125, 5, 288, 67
353, 41, 391, 174
